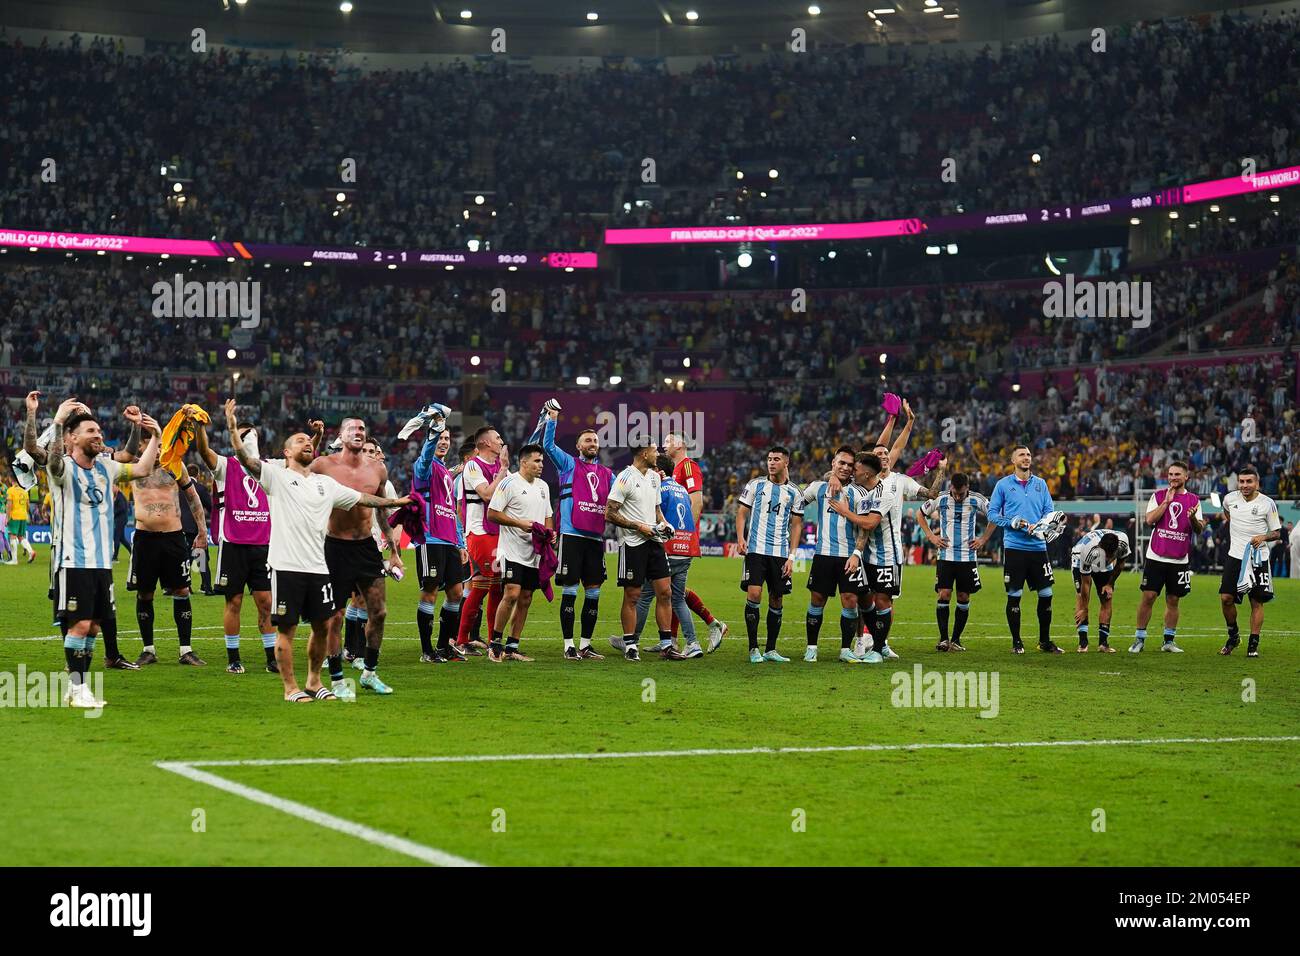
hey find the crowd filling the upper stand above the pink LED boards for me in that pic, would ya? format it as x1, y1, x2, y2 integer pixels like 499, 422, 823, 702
0, 13, 1300, 250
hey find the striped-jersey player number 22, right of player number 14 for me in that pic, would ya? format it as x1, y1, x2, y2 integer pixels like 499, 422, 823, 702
800, 445, 868, 663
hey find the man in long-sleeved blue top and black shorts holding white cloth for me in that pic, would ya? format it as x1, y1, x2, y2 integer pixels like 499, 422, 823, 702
988, 445, 1065, 654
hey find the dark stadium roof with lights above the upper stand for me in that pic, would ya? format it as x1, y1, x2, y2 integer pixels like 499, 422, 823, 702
3, 0, 1278, 57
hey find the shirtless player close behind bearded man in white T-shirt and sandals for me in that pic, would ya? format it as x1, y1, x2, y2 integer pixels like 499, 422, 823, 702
311, 418, 402, 698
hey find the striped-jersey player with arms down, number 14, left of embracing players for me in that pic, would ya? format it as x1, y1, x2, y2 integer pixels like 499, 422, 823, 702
736, 445, 803, 663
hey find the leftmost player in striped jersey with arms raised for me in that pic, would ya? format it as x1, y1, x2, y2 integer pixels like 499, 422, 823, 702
46, 398, 163, 709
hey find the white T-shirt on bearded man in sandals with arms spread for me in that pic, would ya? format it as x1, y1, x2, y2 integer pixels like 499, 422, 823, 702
259, 458, 361, 575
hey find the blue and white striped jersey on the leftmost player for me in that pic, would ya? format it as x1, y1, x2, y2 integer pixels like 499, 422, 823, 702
46, 455, 131, 571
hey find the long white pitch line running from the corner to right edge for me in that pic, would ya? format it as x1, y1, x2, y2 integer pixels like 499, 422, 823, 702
175, 736, 1300, 775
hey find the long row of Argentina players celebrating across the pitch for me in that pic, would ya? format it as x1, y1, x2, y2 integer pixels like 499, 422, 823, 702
14, 392, 1281, 708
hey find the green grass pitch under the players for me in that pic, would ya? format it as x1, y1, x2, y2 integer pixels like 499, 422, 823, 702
0, 548, 1300, 866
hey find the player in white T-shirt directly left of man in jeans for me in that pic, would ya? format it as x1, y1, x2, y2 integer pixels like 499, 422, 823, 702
605, 442, 683, 661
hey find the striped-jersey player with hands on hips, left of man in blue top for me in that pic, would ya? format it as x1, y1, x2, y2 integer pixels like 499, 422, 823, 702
920, 471, 995, 652
